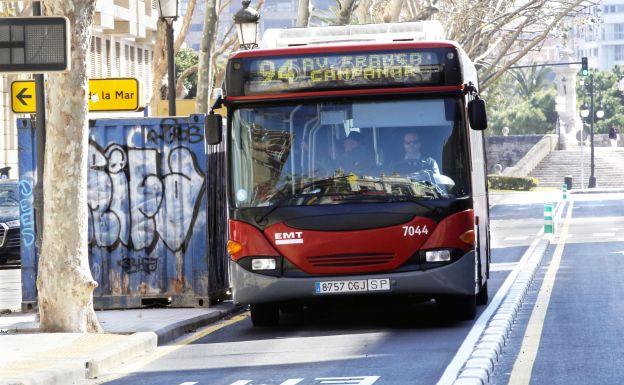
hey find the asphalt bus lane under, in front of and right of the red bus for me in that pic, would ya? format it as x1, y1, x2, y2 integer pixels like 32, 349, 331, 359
96, 195, 543, 385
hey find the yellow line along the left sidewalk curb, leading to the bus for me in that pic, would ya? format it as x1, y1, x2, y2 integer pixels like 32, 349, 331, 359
97, 312, 249, 385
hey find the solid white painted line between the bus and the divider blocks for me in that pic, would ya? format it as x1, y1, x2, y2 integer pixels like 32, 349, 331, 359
437, 227, 544, 385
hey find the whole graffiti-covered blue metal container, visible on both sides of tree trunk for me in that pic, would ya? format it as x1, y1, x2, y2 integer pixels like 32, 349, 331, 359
18, 115, 229, 308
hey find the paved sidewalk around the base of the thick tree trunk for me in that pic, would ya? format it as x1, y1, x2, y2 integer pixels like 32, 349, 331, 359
0, 302, 242, 385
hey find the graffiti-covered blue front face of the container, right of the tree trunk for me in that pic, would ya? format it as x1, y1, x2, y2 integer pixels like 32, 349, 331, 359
88, 115, 207, 304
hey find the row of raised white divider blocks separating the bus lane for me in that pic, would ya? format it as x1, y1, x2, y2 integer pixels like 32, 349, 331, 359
452, 202, 567, 385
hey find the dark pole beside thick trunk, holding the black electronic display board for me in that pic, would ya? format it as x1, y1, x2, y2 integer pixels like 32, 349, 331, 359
32, 1, 46, 253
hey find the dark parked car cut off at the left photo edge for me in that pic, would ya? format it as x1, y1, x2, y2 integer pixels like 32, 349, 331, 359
0, 179, 20, 265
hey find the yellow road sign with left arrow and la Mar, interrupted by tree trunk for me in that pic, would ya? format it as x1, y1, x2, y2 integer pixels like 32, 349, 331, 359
11, 78, 139, 114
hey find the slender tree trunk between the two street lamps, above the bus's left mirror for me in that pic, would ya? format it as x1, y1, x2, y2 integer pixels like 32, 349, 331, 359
196, 0, 219, 114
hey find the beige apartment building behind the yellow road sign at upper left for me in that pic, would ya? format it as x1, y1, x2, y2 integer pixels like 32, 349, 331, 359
0, 0, 158, 178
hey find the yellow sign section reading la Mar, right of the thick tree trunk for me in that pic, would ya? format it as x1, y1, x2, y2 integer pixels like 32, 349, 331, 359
89, 78, 139, 112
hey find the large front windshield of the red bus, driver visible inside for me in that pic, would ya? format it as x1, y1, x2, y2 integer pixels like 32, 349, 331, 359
230, 98, 470, 207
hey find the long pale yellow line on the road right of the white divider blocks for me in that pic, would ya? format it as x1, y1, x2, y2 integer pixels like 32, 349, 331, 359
508, 198, 574, 385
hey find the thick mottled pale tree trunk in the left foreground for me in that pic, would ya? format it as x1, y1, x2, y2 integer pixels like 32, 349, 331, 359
37, 0, 101, 333
